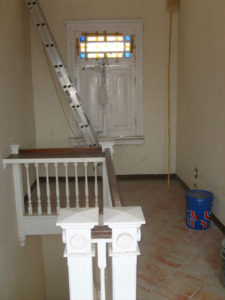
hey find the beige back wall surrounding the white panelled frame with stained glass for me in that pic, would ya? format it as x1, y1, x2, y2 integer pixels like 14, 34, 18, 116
31, 0, 177, 174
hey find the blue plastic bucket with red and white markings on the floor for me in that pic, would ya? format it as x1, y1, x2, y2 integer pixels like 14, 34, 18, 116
186, 190, 213, 230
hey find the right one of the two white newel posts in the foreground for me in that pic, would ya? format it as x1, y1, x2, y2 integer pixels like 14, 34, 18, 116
104, 207, 145, 300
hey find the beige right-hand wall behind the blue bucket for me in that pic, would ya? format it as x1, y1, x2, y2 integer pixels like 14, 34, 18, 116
177, 0, 225, 224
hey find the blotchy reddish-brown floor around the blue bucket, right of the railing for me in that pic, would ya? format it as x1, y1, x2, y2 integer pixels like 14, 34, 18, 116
119, 180, 225, 300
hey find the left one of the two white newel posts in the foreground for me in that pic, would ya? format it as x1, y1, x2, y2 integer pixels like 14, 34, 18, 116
56, 208, 98, 300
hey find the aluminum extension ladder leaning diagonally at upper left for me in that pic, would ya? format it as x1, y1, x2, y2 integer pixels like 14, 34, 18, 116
25, 0, 97, 147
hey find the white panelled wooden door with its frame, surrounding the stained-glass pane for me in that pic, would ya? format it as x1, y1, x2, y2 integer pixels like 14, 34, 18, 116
66, 20, 143, 137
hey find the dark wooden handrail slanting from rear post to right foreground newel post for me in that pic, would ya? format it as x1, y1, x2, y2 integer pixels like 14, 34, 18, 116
105, 149, 122, 207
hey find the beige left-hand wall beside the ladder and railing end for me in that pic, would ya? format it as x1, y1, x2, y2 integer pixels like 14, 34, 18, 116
0, 0, 45, 300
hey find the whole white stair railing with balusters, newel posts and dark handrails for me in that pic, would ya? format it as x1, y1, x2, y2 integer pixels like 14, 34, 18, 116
3, 147, 145, 300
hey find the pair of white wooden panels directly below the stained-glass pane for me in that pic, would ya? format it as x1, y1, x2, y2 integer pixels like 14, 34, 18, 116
77, 64, 135, 137
